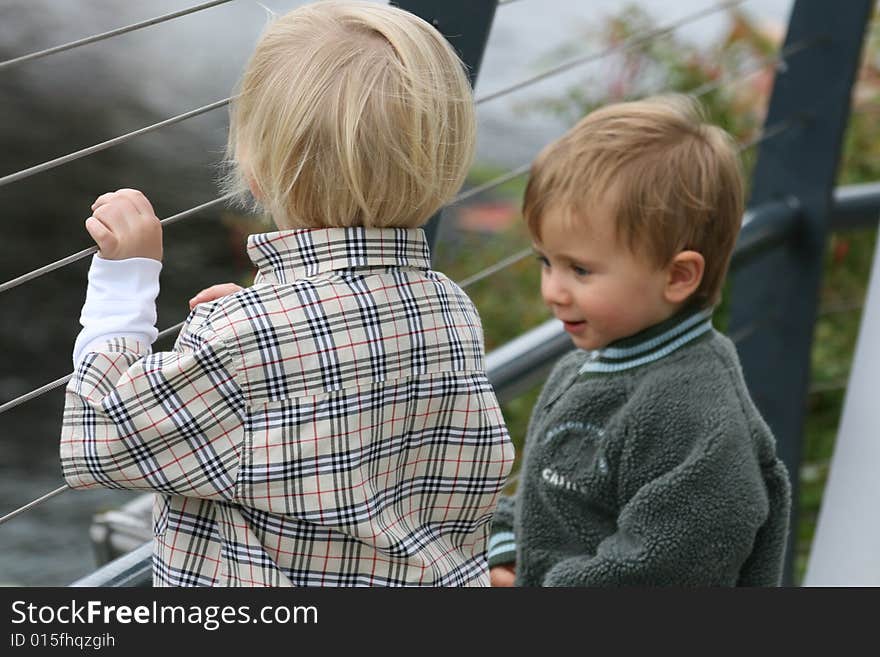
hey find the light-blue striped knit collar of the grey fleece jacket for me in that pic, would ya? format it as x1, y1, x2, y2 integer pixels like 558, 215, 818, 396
578, 308, 713, 374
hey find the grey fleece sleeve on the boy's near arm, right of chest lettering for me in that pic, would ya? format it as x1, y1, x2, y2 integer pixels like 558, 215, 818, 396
543, 428, 768, 586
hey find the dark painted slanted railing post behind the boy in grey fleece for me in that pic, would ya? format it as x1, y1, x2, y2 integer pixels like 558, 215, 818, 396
728, 0, 873, 584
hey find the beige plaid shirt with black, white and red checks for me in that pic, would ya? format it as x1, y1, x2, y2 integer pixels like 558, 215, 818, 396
61, 228, 513, 586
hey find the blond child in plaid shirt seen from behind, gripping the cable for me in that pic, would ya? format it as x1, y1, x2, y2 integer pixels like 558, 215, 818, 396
61, 2, 513, 586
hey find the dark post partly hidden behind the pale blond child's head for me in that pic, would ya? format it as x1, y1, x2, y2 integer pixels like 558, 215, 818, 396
391, 0, 498, 252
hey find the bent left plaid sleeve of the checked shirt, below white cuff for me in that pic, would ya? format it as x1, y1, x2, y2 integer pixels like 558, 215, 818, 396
60, 329, 246, 500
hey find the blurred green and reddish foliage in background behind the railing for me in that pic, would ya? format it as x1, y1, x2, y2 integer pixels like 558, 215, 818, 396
446, 7, 880, 582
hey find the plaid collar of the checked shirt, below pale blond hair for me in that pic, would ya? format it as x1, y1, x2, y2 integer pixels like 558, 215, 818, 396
247, 227, 431, 283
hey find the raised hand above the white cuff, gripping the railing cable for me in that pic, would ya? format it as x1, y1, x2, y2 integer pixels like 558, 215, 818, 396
86, 189, 162, 262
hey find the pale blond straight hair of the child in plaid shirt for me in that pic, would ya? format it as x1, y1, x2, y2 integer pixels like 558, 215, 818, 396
226, 1, 476, 229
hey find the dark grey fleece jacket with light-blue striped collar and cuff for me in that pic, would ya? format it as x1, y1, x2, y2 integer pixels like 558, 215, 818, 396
489, 304, 791, 586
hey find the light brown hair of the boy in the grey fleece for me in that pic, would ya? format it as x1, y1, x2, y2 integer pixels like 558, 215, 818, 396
523, 95, 743, 306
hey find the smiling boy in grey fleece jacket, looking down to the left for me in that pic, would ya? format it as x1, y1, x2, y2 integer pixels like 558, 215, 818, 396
490, 96, 790, 586
